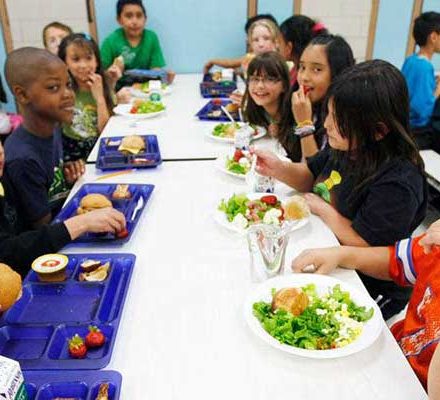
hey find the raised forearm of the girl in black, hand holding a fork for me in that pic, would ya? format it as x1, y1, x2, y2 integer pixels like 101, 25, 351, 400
253, 149, 315, 192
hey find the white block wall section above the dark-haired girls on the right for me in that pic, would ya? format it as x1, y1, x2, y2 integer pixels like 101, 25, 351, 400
301, 0, 371, 62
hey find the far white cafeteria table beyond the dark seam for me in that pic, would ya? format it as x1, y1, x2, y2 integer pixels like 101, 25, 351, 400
87, 74, 278, 162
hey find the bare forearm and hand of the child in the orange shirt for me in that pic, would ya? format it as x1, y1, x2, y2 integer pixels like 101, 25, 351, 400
292, 246, 391, 280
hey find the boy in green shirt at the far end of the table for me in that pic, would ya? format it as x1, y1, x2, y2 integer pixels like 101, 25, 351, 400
101, 0, 174, 88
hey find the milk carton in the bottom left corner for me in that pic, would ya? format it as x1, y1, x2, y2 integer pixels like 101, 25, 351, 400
0, 356, 28, 400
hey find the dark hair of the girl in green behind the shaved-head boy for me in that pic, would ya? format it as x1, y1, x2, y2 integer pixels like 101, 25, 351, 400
58, 33, 114, 113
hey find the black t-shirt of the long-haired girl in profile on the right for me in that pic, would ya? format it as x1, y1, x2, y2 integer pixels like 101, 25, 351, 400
308, 149, 428, 319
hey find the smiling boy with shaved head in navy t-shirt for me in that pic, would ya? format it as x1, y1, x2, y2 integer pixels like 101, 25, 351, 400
5, 47, 84, 230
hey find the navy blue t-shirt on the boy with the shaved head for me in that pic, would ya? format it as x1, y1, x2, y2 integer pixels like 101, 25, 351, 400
4, 126, 68, 229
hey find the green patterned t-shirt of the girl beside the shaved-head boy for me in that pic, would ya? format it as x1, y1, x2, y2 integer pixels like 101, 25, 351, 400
63, 91, 99, 140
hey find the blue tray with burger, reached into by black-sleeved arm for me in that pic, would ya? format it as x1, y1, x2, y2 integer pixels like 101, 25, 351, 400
53, 183, 154, 246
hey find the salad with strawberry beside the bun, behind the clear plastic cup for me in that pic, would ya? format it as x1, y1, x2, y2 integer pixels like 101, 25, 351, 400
218, 194, 284, 229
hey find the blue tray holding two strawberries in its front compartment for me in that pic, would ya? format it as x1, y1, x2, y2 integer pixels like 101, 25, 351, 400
0, 253, 136, 370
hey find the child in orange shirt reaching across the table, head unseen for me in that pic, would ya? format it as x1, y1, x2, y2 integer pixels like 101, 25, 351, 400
292, 220, 440, 388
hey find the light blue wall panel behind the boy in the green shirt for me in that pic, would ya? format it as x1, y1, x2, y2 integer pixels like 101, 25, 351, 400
95, 0, 247, 73
